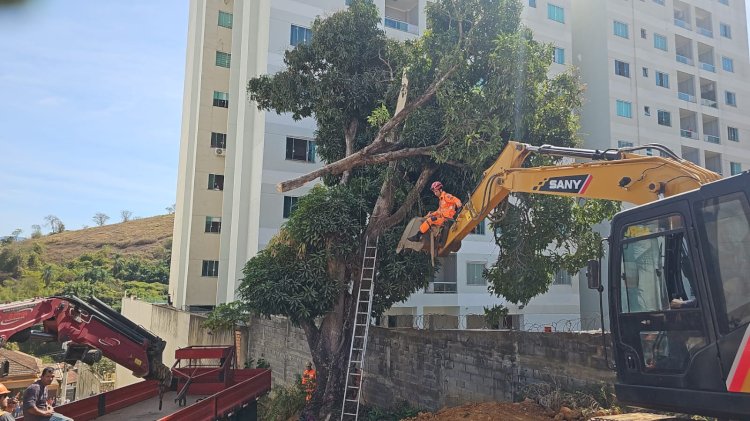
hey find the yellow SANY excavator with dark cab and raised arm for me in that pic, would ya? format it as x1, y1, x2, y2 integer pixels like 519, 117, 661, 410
398, 142, 750, 419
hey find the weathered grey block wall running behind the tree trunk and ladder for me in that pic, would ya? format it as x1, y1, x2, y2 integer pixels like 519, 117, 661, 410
248, 318, 614, 410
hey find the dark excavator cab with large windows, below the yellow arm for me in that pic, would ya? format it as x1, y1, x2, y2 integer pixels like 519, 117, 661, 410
608, 173, 750, 419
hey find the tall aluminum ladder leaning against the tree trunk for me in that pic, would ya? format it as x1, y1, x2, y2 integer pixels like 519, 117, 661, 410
341, 237, 379, 421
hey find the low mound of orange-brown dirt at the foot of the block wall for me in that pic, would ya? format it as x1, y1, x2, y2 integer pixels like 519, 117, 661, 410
402, 400, 556, 421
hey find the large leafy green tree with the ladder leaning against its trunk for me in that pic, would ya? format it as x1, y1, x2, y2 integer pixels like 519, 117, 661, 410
244, 0, 606, 419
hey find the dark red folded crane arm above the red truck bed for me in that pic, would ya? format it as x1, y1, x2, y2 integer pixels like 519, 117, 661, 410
0, 296, 171, 385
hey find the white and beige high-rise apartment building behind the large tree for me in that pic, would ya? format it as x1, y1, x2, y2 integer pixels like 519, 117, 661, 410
169, 0, 750, 328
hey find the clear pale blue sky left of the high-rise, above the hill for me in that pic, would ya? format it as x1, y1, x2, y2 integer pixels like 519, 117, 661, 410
0, 0, 189, 236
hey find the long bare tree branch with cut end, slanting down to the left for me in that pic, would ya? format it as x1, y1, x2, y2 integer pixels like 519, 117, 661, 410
276, 64, 458, 193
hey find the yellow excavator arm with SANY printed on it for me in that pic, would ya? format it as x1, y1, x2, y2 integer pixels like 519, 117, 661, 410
402, 141, 721, 256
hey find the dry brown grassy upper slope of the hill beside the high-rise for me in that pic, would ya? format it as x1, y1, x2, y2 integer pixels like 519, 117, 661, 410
32, 215, 174, 263
